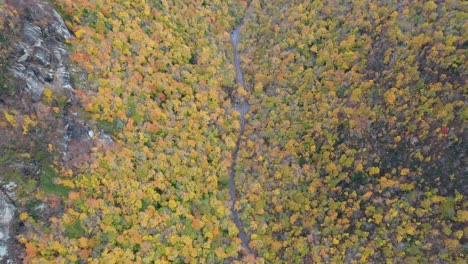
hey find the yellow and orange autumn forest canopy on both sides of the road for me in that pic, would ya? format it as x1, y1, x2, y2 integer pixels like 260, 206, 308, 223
16, 0, 468, 263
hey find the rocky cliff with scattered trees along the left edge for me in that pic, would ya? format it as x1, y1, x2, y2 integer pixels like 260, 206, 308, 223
0, 0, 94, 263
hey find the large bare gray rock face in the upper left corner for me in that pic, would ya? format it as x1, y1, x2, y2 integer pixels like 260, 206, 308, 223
11, 0, 72, 103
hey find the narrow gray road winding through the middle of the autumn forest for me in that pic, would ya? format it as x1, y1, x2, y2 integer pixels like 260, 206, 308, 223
229, 15, 255, 255
